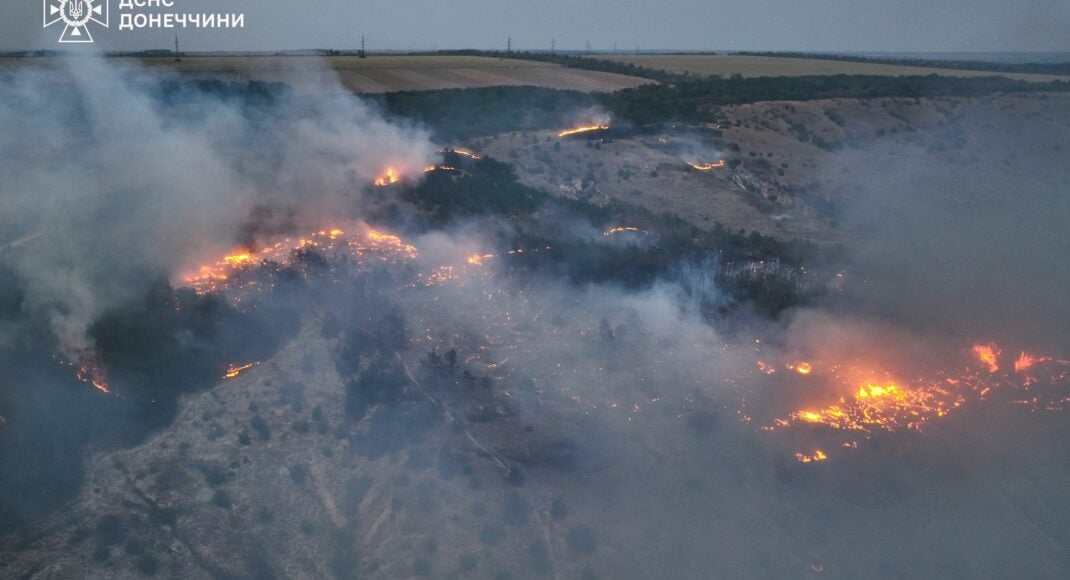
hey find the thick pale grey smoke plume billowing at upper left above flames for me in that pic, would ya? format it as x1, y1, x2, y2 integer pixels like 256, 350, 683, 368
0, 58, 433, 351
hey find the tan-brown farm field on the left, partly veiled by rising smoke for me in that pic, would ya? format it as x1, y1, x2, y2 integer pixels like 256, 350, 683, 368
0, 56, 651, 93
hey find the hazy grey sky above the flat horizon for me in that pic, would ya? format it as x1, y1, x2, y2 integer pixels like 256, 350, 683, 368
0, 0, 1070, 51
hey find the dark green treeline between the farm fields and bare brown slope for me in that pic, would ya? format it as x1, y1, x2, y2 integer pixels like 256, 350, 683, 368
368, 70, 1070, 139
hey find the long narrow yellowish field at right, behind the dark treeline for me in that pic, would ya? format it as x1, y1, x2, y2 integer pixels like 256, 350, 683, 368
598, 55, 1067, 82
